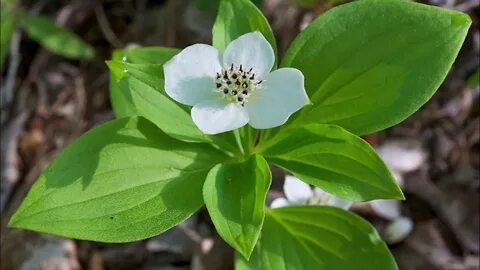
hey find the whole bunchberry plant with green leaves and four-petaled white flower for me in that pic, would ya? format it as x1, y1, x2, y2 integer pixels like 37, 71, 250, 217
10, 0, 470, 270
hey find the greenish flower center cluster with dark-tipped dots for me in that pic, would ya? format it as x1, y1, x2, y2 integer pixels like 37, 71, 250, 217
215, 64, 263, 106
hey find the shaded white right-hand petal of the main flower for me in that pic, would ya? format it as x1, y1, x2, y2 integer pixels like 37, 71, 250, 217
245, 68, 309, 129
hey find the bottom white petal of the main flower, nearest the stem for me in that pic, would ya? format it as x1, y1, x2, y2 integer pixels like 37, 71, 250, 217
191, 98, 248, 134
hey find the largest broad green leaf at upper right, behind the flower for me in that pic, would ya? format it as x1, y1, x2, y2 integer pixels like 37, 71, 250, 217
282, 0, 471, 135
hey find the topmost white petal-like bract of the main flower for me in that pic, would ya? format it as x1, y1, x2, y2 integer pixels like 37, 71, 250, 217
223, 32, 275, 79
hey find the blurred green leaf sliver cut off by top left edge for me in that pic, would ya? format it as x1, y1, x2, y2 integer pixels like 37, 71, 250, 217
0, 1, 15, 69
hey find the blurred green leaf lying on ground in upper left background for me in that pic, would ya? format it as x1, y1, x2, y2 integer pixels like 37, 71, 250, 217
20, 13, 95, 59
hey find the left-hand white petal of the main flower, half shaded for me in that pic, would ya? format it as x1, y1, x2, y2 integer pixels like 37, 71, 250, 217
163, 44, 222, 106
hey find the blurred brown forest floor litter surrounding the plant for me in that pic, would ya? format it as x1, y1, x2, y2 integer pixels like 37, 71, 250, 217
0, 0, 480, 270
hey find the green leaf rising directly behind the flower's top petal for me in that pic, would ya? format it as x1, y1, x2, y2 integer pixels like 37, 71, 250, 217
212, 0, 277, 61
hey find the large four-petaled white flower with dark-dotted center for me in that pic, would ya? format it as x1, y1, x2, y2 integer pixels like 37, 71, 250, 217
164, 32, 309, 134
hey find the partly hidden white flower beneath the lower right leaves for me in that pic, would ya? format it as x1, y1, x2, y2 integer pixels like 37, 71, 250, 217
270, 175, 352, 209
